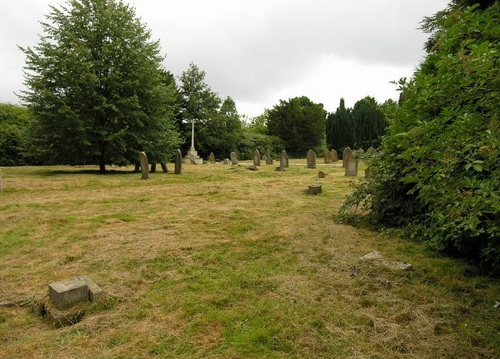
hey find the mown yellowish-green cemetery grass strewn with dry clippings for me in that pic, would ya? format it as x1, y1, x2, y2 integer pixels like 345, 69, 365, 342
0, 159, 500, 359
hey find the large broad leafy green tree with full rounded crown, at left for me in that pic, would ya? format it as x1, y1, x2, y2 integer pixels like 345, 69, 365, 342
21, 0, 179, 171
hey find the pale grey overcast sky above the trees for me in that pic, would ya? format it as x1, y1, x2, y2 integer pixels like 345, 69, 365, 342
0, 0, 449, 117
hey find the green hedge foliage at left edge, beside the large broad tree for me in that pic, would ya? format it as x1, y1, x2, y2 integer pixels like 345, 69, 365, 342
0, 103, 30, 166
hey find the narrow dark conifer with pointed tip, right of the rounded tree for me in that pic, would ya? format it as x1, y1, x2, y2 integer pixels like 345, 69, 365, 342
326, 98, 356, 153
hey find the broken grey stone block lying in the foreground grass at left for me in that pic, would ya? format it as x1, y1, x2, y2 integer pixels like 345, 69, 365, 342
49, 276, 104, 310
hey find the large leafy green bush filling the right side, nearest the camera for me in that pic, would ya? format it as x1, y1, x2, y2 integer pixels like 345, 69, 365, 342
341, 3, 500, 274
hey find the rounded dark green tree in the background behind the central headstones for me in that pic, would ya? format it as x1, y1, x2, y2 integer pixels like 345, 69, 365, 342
267, 96, 326, 156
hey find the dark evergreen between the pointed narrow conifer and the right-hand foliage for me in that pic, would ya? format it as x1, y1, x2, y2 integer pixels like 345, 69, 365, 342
351, 97, 386, 150
